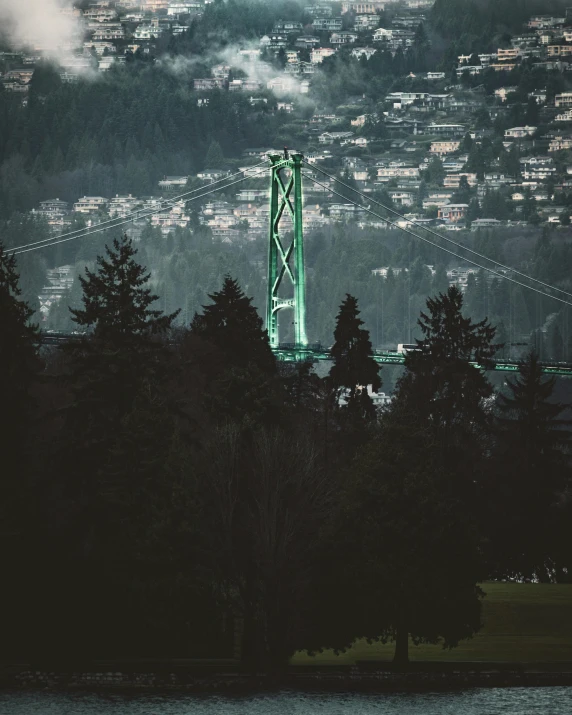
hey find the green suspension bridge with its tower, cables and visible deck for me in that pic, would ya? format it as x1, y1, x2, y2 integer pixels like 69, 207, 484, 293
12, 149, 572, 376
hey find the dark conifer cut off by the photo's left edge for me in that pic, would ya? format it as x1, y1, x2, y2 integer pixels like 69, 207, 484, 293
0, 244, 41, 657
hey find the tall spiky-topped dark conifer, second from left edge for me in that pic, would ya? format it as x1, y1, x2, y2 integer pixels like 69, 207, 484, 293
46, 238, 180, 652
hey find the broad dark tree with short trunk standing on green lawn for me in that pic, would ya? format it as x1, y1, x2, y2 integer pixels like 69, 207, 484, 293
303, 403, 484, 668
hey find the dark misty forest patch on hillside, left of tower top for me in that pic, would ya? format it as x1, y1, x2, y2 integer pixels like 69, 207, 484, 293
0, 69, 290, 218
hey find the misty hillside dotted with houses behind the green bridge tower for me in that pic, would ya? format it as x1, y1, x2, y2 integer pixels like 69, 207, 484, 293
0, 0, 572, 356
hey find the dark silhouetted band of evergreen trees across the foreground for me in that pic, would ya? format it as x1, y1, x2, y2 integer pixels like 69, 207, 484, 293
0, 240, 572, 668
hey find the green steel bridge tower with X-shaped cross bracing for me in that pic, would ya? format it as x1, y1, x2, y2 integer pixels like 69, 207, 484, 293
266, 150, 308, 349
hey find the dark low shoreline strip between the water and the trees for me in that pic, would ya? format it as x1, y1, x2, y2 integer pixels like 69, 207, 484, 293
0, 664, 572, 695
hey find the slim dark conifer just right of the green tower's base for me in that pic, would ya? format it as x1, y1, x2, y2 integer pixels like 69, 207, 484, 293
330, 293, 381, 418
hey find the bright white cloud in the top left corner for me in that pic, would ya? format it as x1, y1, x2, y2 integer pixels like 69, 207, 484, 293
0, 0, 81, 55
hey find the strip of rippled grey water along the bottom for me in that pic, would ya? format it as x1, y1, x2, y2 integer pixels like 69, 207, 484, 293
0, 687, 572, 715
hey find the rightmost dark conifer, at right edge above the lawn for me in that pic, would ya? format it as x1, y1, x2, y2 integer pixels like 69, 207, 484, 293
488, 352, 570, 581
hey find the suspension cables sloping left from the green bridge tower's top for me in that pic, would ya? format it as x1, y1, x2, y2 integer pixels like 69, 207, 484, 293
8, 162, 267, 255
